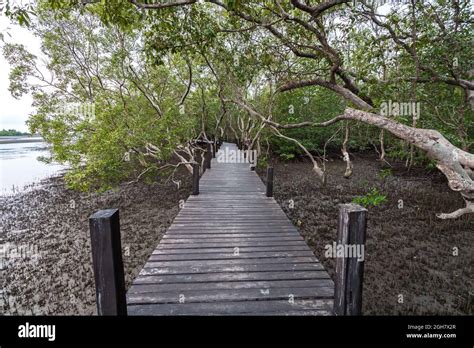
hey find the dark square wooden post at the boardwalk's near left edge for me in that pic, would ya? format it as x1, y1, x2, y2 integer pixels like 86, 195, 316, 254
89, 209, 127, 315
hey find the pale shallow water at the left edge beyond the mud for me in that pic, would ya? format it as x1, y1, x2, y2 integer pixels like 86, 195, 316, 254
0, 137, 66, 195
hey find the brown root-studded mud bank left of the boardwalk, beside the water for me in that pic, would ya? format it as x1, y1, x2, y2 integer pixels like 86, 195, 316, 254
0, 176, 190, 315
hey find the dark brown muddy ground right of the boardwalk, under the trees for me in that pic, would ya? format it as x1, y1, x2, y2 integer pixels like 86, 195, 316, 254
259, 155, 474, 315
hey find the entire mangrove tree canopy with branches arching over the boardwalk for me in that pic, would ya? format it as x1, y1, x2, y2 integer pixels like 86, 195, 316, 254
3, 0, 474, 218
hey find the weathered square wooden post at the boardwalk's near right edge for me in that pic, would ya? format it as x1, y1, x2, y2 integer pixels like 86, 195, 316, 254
334, 203, 367, 315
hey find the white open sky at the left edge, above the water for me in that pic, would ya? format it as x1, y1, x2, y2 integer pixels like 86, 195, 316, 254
0, 16, 41, 132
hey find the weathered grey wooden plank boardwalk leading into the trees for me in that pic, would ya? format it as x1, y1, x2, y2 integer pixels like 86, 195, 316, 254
127, 143, 334, 315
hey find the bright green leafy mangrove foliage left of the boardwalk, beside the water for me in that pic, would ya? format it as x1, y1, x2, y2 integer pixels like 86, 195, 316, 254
10, 11, 205, 190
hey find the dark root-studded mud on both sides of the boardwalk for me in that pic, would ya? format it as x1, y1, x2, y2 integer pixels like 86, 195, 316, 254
0, 156, 474, 315
